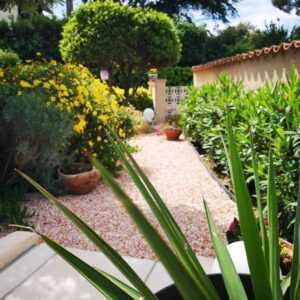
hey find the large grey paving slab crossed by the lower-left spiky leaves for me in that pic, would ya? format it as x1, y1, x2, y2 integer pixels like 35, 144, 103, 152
5, 250, 154, 300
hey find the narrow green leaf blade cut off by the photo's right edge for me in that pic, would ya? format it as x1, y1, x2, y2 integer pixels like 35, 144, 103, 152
290, 179, 300, 300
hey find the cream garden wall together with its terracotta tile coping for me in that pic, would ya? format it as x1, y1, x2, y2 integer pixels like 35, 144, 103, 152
192, 41, 300, 89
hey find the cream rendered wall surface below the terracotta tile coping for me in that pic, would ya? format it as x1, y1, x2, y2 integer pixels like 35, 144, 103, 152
193, 48, 300, 89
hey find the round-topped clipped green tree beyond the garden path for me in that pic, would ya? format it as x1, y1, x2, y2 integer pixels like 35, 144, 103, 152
60, 1, 181, 99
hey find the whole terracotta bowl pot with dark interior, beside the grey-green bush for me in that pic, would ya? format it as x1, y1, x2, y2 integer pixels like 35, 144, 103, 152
58, 162, 100, 194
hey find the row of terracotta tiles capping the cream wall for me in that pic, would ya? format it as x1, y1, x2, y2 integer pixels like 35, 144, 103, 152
192, 40, 300, 71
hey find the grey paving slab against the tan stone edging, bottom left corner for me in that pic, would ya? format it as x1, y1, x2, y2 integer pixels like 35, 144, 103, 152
0, 244, 54, 299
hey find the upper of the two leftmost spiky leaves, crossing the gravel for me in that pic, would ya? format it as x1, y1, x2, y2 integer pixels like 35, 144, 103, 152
17, 171, 157, 300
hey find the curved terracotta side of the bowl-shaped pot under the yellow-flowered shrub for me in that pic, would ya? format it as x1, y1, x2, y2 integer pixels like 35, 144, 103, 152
58, 167, 100, 195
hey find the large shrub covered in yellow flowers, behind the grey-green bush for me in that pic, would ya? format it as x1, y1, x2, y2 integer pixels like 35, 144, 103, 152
0, 61, 132, 168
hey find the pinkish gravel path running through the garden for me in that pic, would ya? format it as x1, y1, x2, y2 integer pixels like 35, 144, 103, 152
28, 134, 236, 258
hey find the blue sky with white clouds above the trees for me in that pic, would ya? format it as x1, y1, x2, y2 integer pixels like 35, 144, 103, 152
55, 0, 300, 31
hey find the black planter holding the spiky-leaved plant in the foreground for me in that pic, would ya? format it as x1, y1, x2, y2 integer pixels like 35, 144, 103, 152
156, 274, 255, 300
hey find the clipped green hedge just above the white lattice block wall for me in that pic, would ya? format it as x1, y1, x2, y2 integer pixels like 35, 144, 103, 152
159, 66, 193, 86
